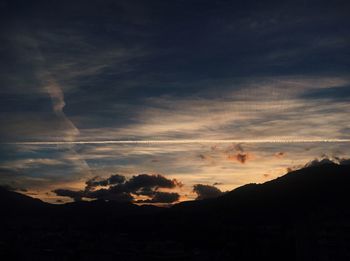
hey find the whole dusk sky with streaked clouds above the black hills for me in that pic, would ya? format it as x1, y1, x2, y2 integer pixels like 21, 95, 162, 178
0, 0, 350, 204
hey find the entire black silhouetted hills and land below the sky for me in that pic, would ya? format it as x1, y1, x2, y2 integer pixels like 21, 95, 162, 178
0, 162, 350, 260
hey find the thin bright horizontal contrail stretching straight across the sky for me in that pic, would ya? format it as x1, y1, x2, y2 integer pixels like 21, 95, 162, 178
2, 139, 350, 145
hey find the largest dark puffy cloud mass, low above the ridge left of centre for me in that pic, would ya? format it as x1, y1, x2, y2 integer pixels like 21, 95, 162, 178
53, 174, 182, 203
